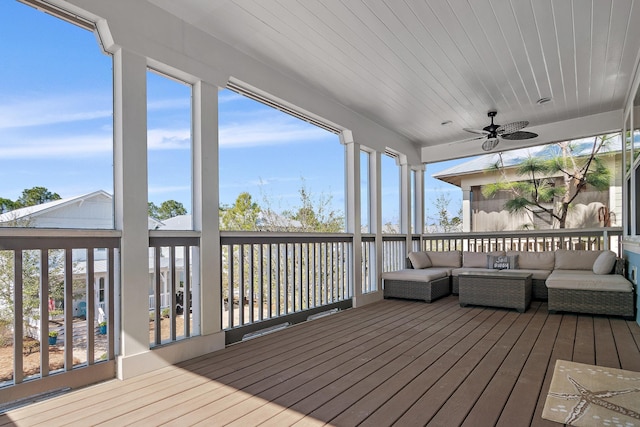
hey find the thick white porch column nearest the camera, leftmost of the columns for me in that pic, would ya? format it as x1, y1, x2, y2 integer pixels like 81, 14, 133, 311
113, 49, 149, 379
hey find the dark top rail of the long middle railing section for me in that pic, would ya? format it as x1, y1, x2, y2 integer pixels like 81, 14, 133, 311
220, 231, 353, 245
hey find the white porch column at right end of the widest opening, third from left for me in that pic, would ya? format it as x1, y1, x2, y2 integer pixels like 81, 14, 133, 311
340, 131, 362, 307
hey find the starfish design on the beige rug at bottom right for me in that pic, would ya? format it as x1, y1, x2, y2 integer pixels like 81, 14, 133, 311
549, 375, 640, 424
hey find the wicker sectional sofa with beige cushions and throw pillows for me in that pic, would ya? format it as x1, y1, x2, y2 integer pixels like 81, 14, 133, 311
382, 249, 635, 318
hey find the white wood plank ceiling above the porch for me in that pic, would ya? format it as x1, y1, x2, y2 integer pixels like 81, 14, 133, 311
149, 0, 640, 157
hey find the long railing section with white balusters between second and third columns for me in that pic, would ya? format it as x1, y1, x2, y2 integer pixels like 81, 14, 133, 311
221, 232, 353, 342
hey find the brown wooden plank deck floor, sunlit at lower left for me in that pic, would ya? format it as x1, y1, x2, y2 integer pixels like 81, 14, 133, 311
0, 296, 640, 427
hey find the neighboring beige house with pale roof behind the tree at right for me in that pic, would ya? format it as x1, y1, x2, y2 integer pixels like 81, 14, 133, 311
433, 138, 622, 232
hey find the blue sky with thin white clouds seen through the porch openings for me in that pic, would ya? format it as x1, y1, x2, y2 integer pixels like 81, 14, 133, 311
0, 0, 461, 229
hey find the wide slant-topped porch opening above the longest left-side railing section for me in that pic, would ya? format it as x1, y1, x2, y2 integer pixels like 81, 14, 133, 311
218, 89, 345, 232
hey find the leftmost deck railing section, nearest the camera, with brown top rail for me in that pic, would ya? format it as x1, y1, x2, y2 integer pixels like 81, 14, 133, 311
0, 229, 120, 392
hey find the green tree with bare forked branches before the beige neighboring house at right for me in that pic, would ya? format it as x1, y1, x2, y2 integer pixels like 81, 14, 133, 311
482, 135, 615, 228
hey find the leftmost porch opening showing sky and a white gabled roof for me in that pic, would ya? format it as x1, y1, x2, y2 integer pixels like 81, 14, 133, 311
0, 1, 113, 229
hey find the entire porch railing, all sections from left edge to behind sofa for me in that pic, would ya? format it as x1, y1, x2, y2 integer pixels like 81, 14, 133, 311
0, 228, 622, 384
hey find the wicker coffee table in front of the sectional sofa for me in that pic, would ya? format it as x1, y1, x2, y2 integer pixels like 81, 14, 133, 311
458, 270, 531, 313
